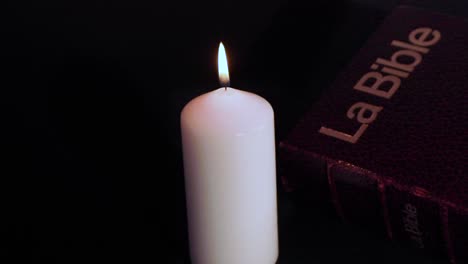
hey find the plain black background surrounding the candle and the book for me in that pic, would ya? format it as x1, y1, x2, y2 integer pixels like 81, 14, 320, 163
0, 0, 468, 264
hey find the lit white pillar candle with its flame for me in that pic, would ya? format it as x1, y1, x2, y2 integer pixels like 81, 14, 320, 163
181, 44, 278, 264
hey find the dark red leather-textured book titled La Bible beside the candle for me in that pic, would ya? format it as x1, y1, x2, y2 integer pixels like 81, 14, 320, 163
279, 7, 468, 263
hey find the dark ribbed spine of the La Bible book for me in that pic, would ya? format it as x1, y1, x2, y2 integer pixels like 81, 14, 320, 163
279, 142, 468, 264
